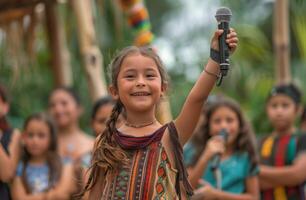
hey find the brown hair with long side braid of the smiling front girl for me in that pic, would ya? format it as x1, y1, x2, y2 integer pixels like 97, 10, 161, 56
80, 46, 168, 196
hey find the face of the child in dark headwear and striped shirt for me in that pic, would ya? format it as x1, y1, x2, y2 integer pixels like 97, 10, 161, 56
266, 94, 297, 130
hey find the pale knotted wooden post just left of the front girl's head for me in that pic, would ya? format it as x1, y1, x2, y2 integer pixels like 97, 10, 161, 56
70, 0, 107, 101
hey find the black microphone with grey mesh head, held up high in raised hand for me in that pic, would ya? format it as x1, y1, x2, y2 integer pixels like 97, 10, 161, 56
215, 7, 232, 77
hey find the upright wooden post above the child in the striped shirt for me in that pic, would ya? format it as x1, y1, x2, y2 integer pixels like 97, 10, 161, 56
273, 0, 291, 84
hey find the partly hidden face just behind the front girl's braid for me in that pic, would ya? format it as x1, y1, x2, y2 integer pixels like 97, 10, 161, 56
92, 104, 114, 135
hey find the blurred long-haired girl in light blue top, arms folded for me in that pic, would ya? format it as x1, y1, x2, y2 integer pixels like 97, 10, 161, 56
12, 114, 73, 200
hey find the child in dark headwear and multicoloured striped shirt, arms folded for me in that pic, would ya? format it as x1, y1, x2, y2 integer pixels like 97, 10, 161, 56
259, 84, 306, 200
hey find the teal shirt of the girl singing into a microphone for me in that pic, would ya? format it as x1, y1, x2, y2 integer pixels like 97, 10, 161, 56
184, 144, 259, 194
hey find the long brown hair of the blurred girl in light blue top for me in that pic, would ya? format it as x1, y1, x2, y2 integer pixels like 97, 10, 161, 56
21, 113, 62, 193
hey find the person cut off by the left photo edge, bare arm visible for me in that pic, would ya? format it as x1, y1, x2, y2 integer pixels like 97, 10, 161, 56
0, 85, 20, 200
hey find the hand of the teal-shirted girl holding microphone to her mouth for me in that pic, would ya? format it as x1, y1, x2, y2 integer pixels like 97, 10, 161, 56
202, 136, 225, 159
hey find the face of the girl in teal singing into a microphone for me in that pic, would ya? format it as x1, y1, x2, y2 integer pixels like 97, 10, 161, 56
209, 106, 239, 144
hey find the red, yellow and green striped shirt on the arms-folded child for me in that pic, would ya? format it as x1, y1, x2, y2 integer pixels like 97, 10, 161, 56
260, 134, 305, 200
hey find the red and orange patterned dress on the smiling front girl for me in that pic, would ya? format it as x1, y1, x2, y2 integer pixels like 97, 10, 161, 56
101, 123, 190, 200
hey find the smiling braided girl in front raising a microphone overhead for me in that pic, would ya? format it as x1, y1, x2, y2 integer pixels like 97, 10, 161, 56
85, 30, 238, 199
